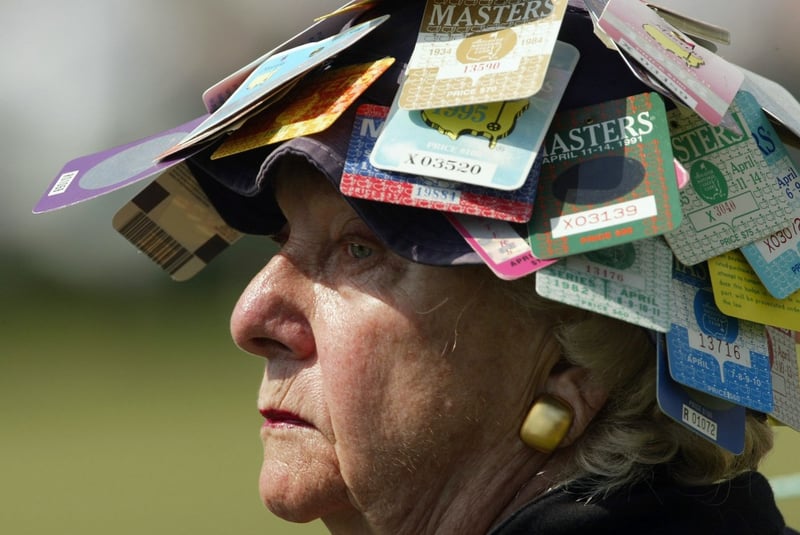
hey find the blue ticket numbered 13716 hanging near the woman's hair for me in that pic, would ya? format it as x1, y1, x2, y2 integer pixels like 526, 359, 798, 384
667, 261, 773, 413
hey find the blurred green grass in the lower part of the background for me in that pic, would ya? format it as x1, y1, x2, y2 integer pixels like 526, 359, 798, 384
0, 245, 800, 535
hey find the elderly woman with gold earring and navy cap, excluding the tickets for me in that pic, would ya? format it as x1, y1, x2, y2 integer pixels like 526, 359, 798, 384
45, 1, 786, 535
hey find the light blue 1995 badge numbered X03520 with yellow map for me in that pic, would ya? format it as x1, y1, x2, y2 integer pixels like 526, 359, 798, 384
370, 42, 579, 190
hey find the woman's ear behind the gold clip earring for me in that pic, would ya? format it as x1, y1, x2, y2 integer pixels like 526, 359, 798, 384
544, 366, 608, 448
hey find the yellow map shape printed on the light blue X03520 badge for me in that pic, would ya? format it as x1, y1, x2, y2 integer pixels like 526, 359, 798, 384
420, 98, 530, 148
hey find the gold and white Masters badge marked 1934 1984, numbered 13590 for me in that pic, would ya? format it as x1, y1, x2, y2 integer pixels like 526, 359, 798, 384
398, 0, 567, 110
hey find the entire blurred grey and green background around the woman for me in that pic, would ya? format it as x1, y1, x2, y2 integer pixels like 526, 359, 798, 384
0, 0, 800, 535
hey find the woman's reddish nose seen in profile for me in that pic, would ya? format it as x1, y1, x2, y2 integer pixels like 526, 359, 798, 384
230, 253, 316, 359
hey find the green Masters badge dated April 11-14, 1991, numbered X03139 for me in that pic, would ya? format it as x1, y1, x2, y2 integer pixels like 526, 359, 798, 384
529, 93, 681, 258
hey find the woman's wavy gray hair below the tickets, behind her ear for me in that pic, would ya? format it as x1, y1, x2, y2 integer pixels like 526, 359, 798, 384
500, 277, 773, 495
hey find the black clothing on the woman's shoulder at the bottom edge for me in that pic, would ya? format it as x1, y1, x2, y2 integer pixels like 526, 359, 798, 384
490, 472, 796, 535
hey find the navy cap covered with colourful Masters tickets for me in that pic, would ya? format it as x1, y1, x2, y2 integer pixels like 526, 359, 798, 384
34, 0, 800, 453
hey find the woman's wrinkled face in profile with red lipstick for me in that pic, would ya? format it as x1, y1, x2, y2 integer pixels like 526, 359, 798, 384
231, 167, 541, 521
